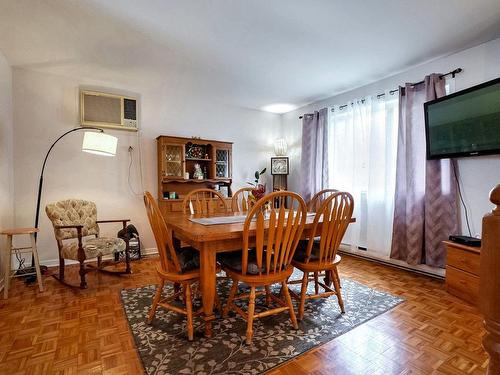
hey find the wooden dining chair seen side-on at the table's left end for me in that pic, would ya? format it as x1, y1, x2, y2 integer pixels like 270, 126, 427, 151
144, 192, 220, 341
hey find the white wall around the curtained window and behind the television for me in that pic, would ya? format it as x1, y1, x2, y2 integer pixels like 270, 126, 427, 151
282, 39, 500, 235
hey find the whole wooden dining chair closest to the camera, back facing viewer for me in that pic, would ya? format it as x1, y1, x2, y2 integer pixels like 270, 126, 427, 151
219, 192, 307, 344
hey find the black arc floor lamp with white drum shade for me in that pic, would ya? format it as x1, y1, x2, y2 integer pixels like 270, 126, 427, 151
31, 126, 118, 278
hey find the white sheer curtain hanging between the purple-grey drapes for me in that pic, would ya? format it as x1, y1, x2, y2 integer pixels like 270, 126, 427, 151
328, 92, 398, 256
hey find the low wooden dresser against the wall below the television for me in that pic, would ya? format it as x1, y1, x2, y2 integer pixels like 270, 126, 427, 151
444, 241, 481, 306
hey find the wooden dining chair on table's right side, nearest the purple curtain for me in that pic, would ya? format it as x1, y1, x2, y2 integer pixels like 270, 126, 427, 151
288, 192, 354, 320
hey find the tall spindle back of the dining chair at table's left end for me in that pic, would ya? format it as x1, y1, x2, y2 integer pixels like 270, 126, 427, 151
144, 191, 181, 273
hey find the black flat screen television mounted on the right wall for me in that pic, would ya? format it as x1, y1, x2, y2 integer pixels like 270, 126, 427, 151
424, 78, 500, 159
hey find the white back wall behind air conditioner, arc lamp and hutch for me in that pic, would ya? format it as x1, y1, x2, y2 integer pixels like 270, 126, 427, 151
13, 68, 280, 263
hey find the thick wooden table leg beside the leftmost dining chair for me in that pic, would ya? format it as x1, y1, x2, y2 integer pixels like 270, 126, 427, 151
200, 243, 217, 337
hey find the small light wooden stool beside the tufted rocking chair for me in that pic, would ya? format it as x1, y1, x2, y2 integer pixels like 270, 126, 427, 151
0, 228, 43, 299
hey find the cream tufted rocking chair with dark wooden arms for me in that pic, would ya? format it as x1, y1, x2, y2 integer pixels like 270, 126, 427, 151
45, 199, 131, 289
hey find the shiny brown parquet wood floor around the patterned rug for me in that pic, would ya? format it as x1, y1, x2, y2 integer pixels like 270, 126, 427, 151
0, 256, 487, 375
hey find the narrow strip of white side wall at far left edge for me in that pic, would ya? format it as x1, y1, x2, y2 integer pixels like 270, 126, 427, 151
0, 51, 14, 275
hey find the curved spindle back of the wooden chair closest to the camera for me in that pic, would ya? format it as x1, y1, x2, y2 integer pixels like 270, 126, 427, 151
242, 191, 307, 276
